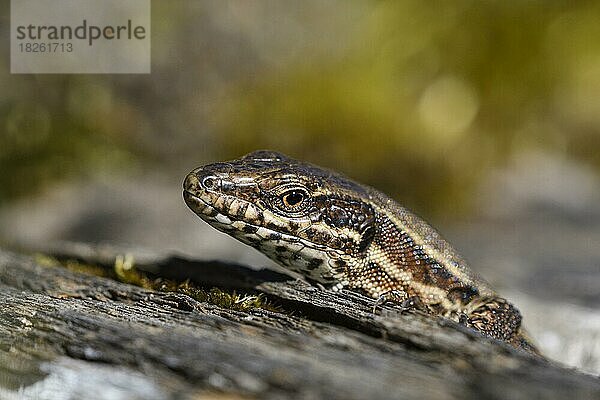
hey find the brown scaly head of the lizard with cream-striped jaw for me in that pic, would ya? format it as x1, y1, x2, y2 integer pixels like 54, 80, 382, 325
183, 151, 375, 287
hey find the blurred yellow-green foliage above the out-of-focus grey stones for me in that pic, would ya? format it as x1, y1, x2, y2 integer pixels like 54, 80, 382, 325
0, 1, 600, 215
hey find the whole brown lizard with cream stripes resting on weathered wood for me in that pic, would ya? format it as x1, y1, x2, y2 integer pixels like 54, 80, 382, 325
183, 150, 539, 354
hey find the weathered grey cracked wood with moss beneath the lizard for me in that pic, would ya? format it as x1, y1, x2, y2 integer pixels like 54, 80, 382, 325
0, 246, 600, 399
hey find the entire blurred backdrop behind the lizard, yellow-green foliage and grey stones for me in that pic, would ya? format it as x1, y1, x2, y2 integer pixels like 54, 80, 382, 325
0, 0, 600, 373
